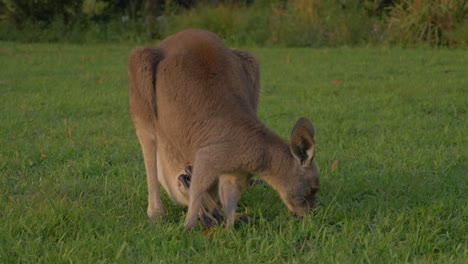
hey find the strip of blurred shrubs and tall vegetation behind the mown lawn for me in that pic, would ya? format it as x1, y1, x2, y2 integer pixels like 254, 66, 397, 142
0, 0, 468, 47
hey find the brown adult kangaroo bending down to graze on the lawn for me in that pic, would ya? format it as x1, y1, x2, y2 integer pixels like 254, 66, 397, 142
128, 29, 319, 230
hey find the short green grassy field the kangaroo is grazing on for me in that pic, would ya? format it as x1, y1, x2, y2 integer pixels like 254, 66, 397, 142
0, 43, 468, 263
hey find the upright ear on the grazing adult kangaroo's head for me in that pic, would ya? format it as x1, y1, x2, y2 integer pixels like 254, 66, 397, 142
289, 117, 315, 167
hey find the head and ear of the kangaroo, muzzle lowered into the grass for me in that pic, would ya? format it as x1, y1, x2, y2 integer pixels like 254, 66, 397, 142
280, 118, 320, 216
